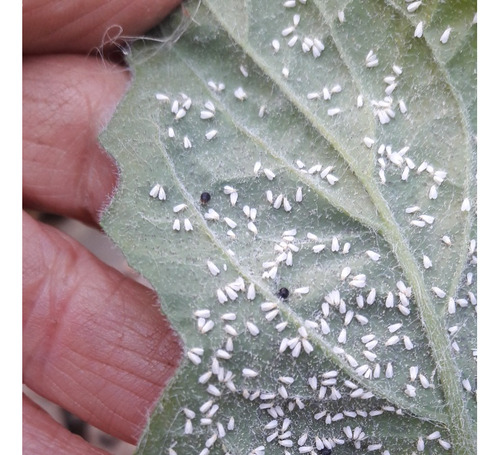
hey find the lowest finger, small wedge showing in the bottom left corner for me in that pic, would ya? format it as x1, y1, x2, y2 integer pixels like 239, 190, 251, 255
23, 396, 109, 455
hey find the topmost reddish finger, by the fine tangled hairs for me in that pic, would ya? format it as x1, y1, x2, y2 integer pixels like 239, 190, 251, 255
23, 0, 180, 54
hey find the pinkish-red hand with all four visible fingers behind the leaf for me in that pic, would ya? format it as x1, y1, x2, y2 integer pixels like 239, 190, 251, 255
23, 0, 180, 455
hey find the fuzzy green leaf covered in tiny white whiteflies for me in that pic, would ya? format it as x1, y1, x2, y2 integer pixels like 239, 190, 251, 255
98, 0, 476, 455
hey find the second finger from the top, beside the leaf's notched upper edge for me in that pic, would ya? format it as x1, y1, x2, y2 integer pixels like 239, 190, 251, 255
23, 55, 128, 228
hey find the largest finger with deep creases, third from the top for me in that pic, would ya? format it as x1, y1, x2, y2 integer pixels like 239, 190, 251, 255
23, 214, 180, 443
